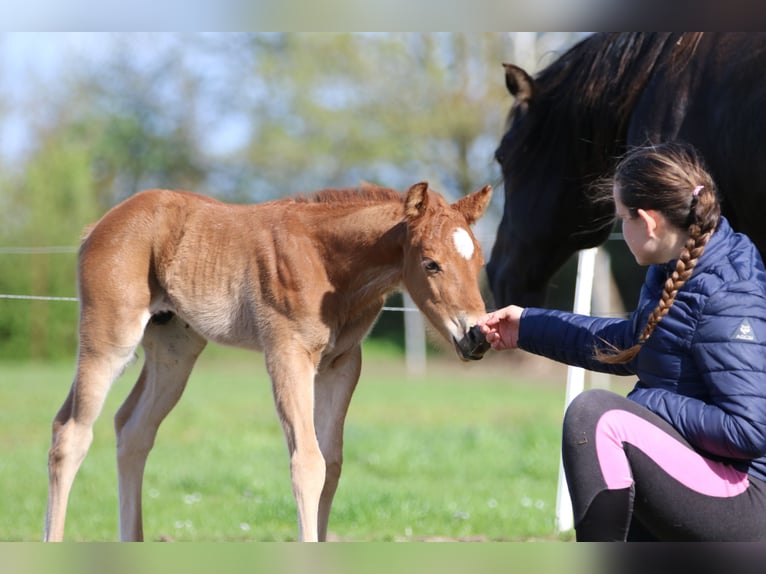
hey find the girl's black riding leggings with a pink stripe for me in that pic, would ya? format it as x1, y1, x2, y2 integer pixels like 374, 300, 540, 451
562, 389, 766, 541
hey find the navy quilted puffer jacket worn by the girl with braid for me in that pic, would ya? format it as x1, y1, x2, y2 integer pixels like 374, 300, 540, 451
519, 218, 766, 480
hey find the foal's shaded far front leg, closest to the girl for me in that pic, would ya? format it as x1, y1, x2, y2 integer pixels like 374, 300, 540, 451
314, 347, 362, 541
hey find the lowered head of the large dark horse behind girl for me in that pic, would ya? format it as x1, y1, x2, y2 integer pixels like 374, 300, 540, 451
486, 64, 614, 307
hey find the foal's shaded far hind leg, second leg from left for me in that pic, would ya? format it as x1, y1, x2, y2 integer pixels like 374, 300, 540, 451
114, 315, 207, 541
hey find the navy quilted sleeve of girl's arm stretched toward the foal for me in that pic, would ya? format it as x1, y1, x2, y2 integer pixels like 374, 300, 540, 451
519, 307, 635, 375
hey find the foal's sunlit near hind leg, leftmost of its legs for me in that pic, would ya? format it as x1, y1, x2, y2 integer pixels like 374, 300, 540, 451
45, 305, 148, 541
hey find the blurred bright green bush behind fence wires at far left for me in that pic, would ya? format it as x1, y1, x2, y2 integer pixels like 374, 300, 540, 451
0, 125, 99, 358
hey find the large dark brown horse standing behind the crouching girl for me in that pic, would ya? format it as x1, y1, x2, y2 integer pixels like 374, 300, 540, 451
487, 33, 766, 306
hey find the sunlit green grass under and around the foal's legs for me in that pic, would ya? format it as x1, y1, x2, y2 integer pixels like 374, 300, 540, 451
0, 348, 576, 541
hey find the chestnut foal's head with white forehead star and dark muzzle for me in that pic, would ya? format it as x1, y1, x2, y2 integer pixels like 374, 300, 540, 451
403, 183, 492, 361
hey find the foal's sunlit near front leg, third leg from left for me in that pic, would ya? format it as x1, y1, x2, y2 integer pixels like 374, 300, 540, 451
266, 349, 325, 542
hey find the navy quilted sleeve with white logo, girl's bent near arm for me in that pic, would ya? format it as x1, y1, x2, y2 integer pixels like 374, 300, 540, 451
630, 284, 766, 459
